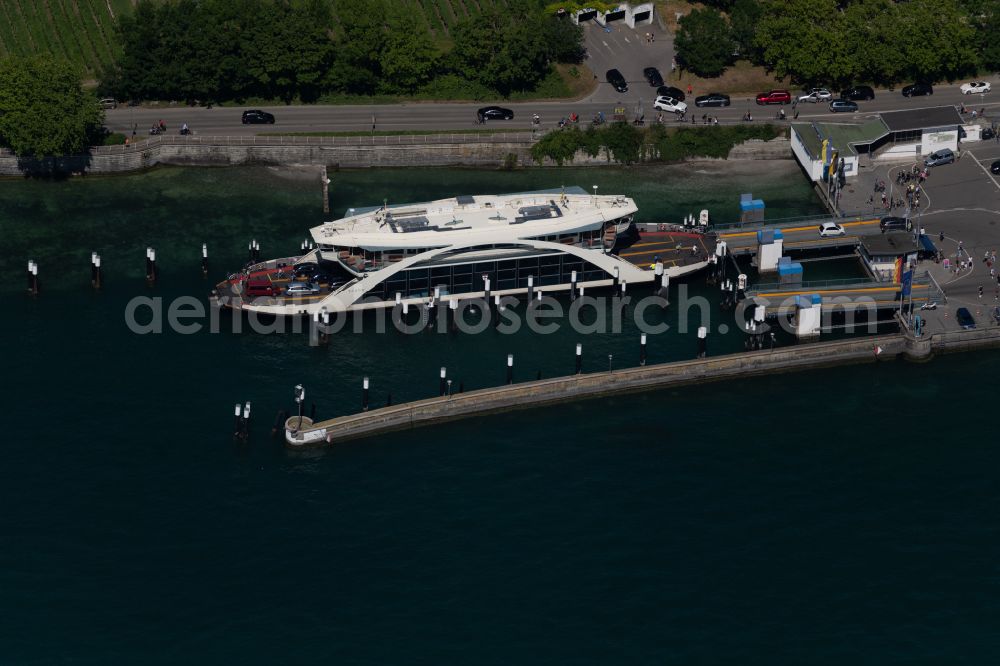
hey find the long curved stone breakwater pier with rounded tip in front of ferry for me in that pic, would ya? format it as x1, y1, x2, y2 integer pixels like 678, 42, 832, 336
285, 328, 1000, 449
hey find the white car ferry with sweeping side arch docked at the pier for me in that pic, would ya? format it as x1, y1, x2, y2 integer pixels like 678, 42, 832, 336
215, 187, 714, 315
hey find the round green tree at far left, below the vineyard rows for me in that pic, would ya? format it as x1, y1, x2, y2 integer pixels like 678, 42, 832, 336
0, 57, 104, 157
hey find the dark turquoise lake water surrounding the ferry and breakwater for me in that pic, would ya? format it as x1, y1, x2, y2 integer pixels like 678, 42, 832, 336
0, 163, 1000, 664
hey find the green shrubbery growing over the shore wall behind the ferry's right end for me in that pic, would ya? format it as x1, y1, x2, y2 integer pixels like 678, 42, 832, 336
531, 123, 784, 165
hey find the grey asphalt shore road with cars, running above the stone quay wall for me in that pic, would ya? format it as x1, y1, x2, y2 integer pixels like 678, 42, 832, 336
105, 77, 1000, 135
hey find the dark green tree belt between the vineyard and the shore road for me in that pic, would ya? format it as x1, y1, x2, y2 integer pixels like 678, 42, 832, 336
100, 0, 583, 102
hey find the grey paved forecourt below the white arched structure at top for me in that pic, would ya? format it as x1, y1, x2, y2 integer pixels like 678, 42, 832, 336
583, 21, 674, 104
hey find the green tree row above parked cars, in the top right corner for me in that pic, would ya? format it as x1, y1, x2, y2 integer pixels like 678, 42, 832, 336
676, 0, 1000, 85
